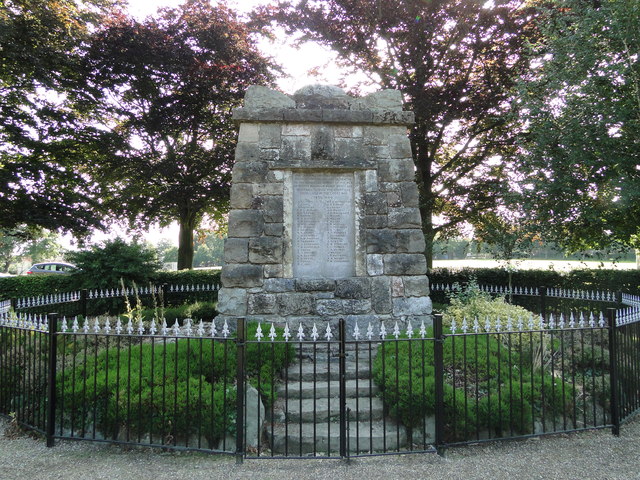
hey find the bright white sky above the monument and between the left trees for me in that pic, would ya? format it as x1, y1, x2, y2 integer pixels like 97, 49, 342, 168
72, 0, 368, 248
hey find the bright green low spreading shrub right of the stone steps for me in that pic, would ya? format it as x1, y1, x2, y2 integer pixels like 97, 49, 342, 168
373, 329, 574, 441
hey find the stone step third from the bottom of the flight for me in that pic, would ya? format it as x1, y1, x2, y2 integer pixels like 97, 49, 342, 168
277, 379, 378, 401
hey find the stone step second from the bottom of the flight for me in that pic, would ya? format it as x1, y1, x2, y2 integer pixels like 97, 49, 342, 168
274, 397, 384, 424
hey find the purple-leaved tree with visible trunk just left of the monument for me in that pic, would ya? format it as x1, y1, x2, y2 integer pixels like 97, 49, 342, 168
86, 0, 271, 269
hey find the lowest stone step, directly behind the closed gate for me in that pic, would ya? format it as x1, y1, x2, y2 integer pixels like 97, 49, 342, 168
267, 420, 407, 456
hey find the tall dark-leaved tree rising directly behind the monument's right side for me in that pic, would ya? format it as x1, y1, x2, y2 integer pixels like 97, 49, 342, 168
255, 0, 535, 266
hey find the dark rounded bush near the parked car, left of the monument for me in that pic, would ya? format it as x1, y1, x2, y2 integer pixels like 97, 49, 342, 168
68, 238, 160, 288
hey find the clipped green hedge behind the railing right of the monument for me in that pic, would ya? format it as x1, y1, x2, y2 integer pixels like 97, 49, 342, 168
429, 268, 640, 295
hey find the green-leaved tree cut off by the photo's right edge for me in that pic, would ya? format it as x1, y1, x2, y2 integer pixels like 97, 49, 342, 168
516, 0, 640, 255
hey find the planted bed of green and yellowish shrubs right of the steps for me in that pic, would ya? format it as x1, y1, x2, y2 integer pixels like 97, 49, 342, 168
373, 285, 609, 442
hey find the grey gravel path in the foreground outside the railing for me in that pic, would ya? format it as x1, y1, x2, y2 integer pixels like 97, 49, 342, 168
0, 418, 640, 480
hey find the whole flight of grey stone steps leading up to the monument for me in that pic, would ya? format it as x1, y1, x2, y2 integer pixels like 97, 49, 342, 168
268, 344, 407, 456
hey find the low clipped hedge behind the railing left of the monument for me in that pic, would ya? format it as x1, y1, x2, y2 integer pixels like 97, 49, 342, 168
0, 270, 220, 300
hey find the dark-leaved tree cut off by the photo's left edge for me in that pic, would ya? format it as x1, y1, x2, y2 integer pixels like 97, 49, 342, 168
0, 0, 117, 235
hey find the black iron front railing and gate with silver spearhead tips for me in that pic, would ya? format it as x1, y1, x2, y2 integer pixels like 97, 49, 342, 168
0, 302, 640, 459
